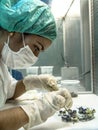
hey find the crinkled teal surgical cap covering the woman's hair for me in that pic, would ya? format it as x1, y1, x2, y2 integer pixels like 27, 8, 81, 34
0, 0, 56, 41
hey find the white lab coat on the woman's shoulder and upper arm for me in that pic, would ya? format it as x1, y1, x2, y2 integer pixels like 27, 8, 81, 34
0, 59, 17, 107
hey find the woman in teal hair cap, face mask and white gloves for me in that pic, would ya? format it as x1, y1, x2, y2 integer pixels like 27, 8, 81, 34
0, 0, 72, 130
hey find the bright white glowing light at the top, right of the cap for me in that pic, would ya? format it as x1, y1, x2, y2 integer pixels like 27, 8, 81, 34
51, 0, 80, 18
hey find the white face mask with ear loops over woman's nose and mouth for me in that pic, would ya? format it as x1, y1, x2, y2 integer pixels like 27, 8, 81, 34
1, 34, 38, 69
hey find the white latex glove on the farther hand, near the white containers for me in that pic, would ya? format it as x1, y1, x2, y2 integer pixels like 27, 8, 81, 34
23, 74, 58, 91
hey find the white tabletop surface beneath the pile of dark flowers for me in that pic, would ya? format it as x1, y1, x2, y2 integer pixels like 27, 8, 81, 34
0, 94, 98, 130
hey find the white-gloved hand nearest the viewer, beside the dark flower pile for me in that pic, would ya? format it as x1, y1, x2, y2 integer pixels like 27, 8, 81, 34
21, 89, 72, 130
